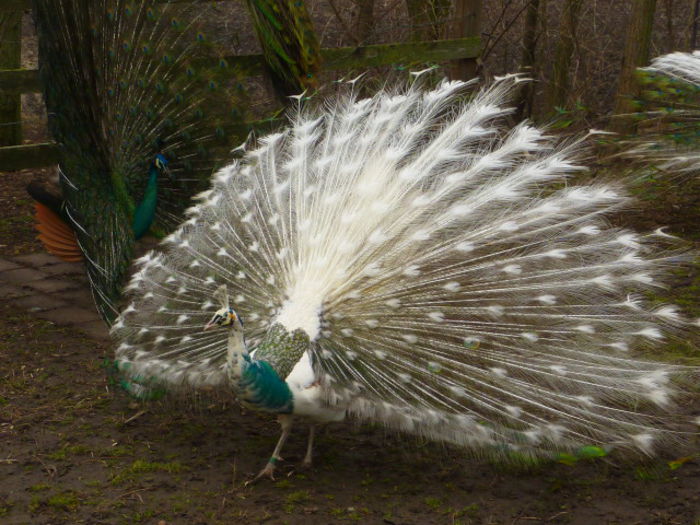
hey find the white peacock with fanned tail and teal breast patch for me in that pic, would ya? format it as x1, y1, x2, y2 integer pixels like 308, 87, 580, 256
112, 76, 700, 477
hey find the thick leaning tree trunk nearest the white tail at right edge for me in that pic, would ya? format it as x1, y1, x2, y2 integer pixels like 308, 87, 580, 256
613, 0, 656, 133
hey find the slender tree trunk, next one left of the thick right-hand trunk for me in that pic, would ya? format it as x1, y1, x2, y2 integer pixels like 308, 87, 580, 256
549, 0, 583, 108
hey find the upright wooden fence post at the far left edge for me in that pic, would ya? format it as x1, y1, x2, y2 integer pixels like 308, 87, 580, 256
0, 10, 22, 146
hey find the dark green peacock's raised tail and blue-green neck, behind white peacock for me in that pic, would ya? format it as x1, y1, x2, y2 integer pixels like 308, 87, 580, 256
34, 0, 252, 320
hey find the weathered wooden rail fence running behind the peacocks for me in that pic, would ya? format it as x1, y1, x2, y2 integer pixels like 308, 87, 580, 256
0, 0, 481, 171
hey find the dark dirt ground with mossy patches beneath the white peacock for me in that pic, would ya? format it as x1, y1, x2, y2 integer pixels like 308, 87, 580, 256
0, 165, 700, 525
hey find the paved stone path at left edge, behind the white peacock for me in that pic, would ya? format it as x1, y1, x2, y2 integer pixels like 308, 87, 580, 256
0, 253, 109, 341
